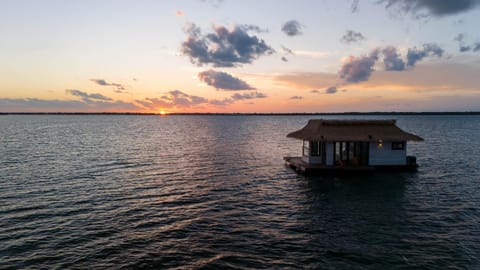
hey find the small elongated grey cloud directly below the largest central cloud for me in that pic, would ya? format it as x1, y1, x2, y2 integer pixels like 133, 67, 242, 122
198, 69, 255, 91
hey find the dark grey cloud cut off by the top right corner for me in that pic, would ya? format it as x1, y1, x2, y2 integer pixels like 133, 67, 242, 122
379, 0, 480, 16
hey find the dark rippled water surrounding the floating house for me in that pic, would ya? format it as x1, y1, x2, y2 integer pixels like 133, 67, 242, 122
0, 115, 480, 269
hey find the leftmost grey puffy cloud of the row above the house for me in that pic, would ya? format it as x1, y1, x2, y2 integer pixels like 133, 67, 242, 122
338, 49, 379, 83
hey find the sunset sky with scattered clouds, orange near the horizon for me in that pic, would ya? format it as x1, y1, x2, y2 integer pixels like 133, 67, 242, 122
0, 0, 480, 113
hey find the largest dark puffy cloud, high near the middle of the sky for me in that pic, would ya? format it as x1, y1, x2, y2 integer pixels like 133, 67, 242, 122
181, 24, 274, 67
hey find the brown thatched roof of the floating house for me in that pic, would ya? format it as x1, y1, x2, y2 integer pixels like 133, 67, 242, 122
287, 119, 423, 142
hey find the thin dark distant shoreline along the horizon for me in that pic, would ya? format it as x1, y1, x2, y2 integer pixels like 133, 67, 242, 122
0, 111, 480, 116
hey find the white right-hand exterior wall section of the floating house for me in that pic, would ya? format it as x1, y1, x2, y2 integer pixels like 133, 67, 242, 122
369, 142, 407, 166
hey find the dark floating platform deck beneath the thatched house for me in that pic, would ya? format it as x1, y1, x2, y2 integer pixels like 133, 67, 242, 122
283, 157, 418, 175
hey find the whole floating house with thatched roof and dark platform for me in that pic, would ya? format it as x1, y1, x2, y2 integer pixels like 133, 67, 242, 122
284, 119, 423, 174
